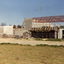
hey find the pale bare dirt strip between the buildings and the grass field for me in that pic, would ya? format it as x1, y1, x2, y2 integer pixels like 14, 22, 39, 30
0, 38, 64, 45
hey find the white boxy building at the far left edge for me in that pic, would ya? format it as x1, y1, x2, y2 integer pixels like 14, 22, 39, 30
0, 26, 13, 37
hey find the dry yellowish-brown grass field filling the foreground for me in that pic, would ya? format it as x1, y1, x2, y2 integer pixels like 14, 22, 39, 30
0, 44, 64, 64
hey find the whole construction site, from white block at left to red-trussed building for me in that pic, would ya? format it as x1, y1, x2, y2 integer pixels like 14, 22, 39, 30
0, 15, 64, 39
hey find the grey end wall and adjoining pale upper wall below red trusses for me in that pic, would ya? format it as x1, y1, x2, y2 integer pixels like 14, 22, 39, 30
22, 18, 53, 30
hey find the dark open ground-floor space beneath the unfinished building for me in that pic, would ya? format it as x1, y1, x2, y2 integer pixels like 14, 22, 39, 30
31, 30, 55, 38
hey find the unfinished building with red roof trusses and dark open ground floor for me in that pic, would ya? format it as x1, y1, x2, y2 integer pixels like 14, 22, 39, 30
22, 16, 64, 38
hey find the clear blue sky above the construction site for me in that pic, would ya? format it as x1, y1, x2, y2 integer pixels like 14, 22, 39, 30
0, 0, 64, 25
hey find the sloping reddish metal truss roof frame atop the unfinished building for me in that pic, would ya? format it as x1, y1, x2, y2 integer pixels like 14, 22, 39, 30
33, 15, 64, 22
